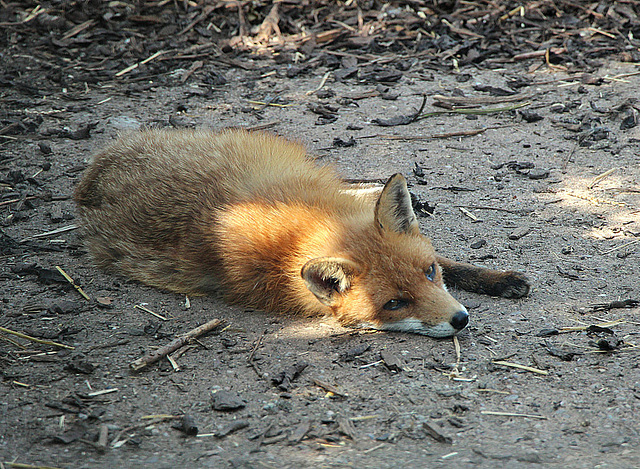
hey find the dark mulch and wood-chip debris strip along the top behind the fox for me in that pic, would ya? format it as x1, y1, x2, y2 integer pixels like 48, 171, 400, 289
0, 0, 640, 105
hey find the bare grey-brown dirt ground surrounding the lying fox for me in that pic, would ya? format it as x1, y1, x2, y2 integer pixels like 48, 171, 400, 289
0, 2, 640, 468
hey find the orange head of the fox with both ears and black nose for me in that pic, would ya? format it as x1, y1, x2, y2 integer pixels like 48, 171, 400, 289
301, 174, 469, 337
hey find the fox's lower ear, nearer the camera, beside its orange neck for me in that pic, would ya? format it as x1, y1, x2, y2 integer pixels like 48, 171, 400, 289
300, 257, 360, 306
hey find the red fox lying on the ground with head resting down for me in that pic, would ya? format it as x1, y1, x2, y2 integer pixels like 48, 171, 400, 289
75, 130, 529, 337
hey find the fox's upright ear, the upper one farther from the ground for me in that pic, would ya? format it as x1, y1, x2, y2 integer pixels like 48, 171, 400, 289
375, 173, 420, 234
